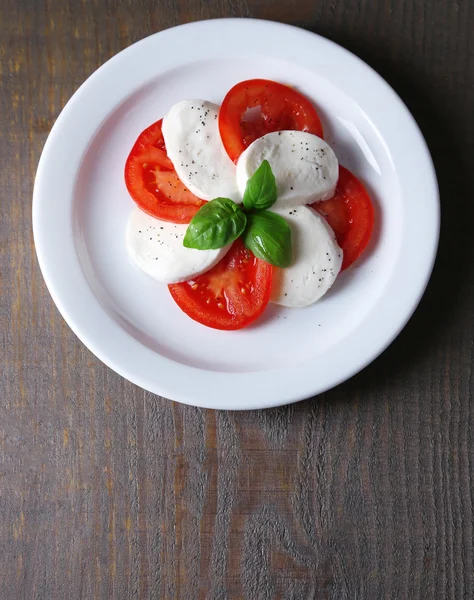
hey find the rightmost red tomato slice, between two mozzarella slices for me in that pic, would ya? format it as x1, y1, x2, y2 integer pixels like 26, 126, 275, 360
311, 165, 374, 271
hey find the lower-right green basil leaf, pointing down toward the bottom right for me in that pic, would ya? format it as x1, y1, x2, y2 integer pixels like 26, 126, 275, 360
243, 210, 292, 268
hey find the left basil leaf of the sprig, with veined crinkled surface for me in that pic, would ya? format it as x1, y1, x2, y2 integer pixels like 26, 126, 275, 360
183, 198, 247, 250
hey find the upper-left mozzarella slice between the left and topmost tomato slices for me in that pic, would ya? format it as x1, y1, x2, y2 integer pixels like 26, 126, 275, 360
162, 100, 241, 202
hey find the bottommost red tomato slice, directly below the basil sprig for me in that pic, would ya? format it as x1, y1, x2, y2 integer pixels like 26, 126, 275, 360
168, 240, 273, 329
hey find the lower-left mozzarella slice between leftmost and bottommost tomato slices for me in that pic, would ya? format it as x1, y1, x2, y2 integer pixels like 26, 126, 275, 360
126, 208, 230, 283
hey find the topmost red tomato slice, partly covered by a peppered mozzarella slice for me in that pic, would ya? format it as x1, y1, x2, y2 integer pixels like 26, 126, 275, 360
219, 79, 323, 162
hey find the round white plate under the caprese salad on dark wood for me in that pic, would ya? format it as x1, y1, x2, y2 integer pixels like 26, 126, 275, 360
33, 19, 439, 409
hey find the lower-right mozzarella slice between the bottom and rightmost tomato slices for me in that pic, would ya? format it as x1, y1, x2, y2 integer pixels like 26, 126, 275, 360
271, 206, 342, 307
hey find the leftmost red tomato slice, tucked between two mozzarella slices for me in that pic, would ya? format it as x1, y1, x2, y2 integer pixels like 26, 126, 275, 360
125, 119, 204, 223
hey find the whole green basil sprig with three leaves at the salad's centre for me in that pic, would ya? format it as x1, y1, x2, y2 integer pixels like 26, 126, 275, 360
183, 160, 292, 268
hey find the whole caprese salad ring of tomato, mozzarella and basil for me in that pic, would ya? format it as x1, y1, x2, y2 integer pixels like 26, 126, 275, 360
125, 79, 374, 330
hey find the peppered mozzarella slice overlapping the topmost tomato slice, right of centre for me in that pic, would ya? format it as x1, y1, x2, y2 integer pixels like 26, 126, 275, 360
237, 131, 339, 209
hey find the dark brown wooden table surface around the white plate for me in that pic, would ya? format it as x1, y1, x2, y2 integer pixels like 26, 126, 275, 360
0, 0, 474, 600
